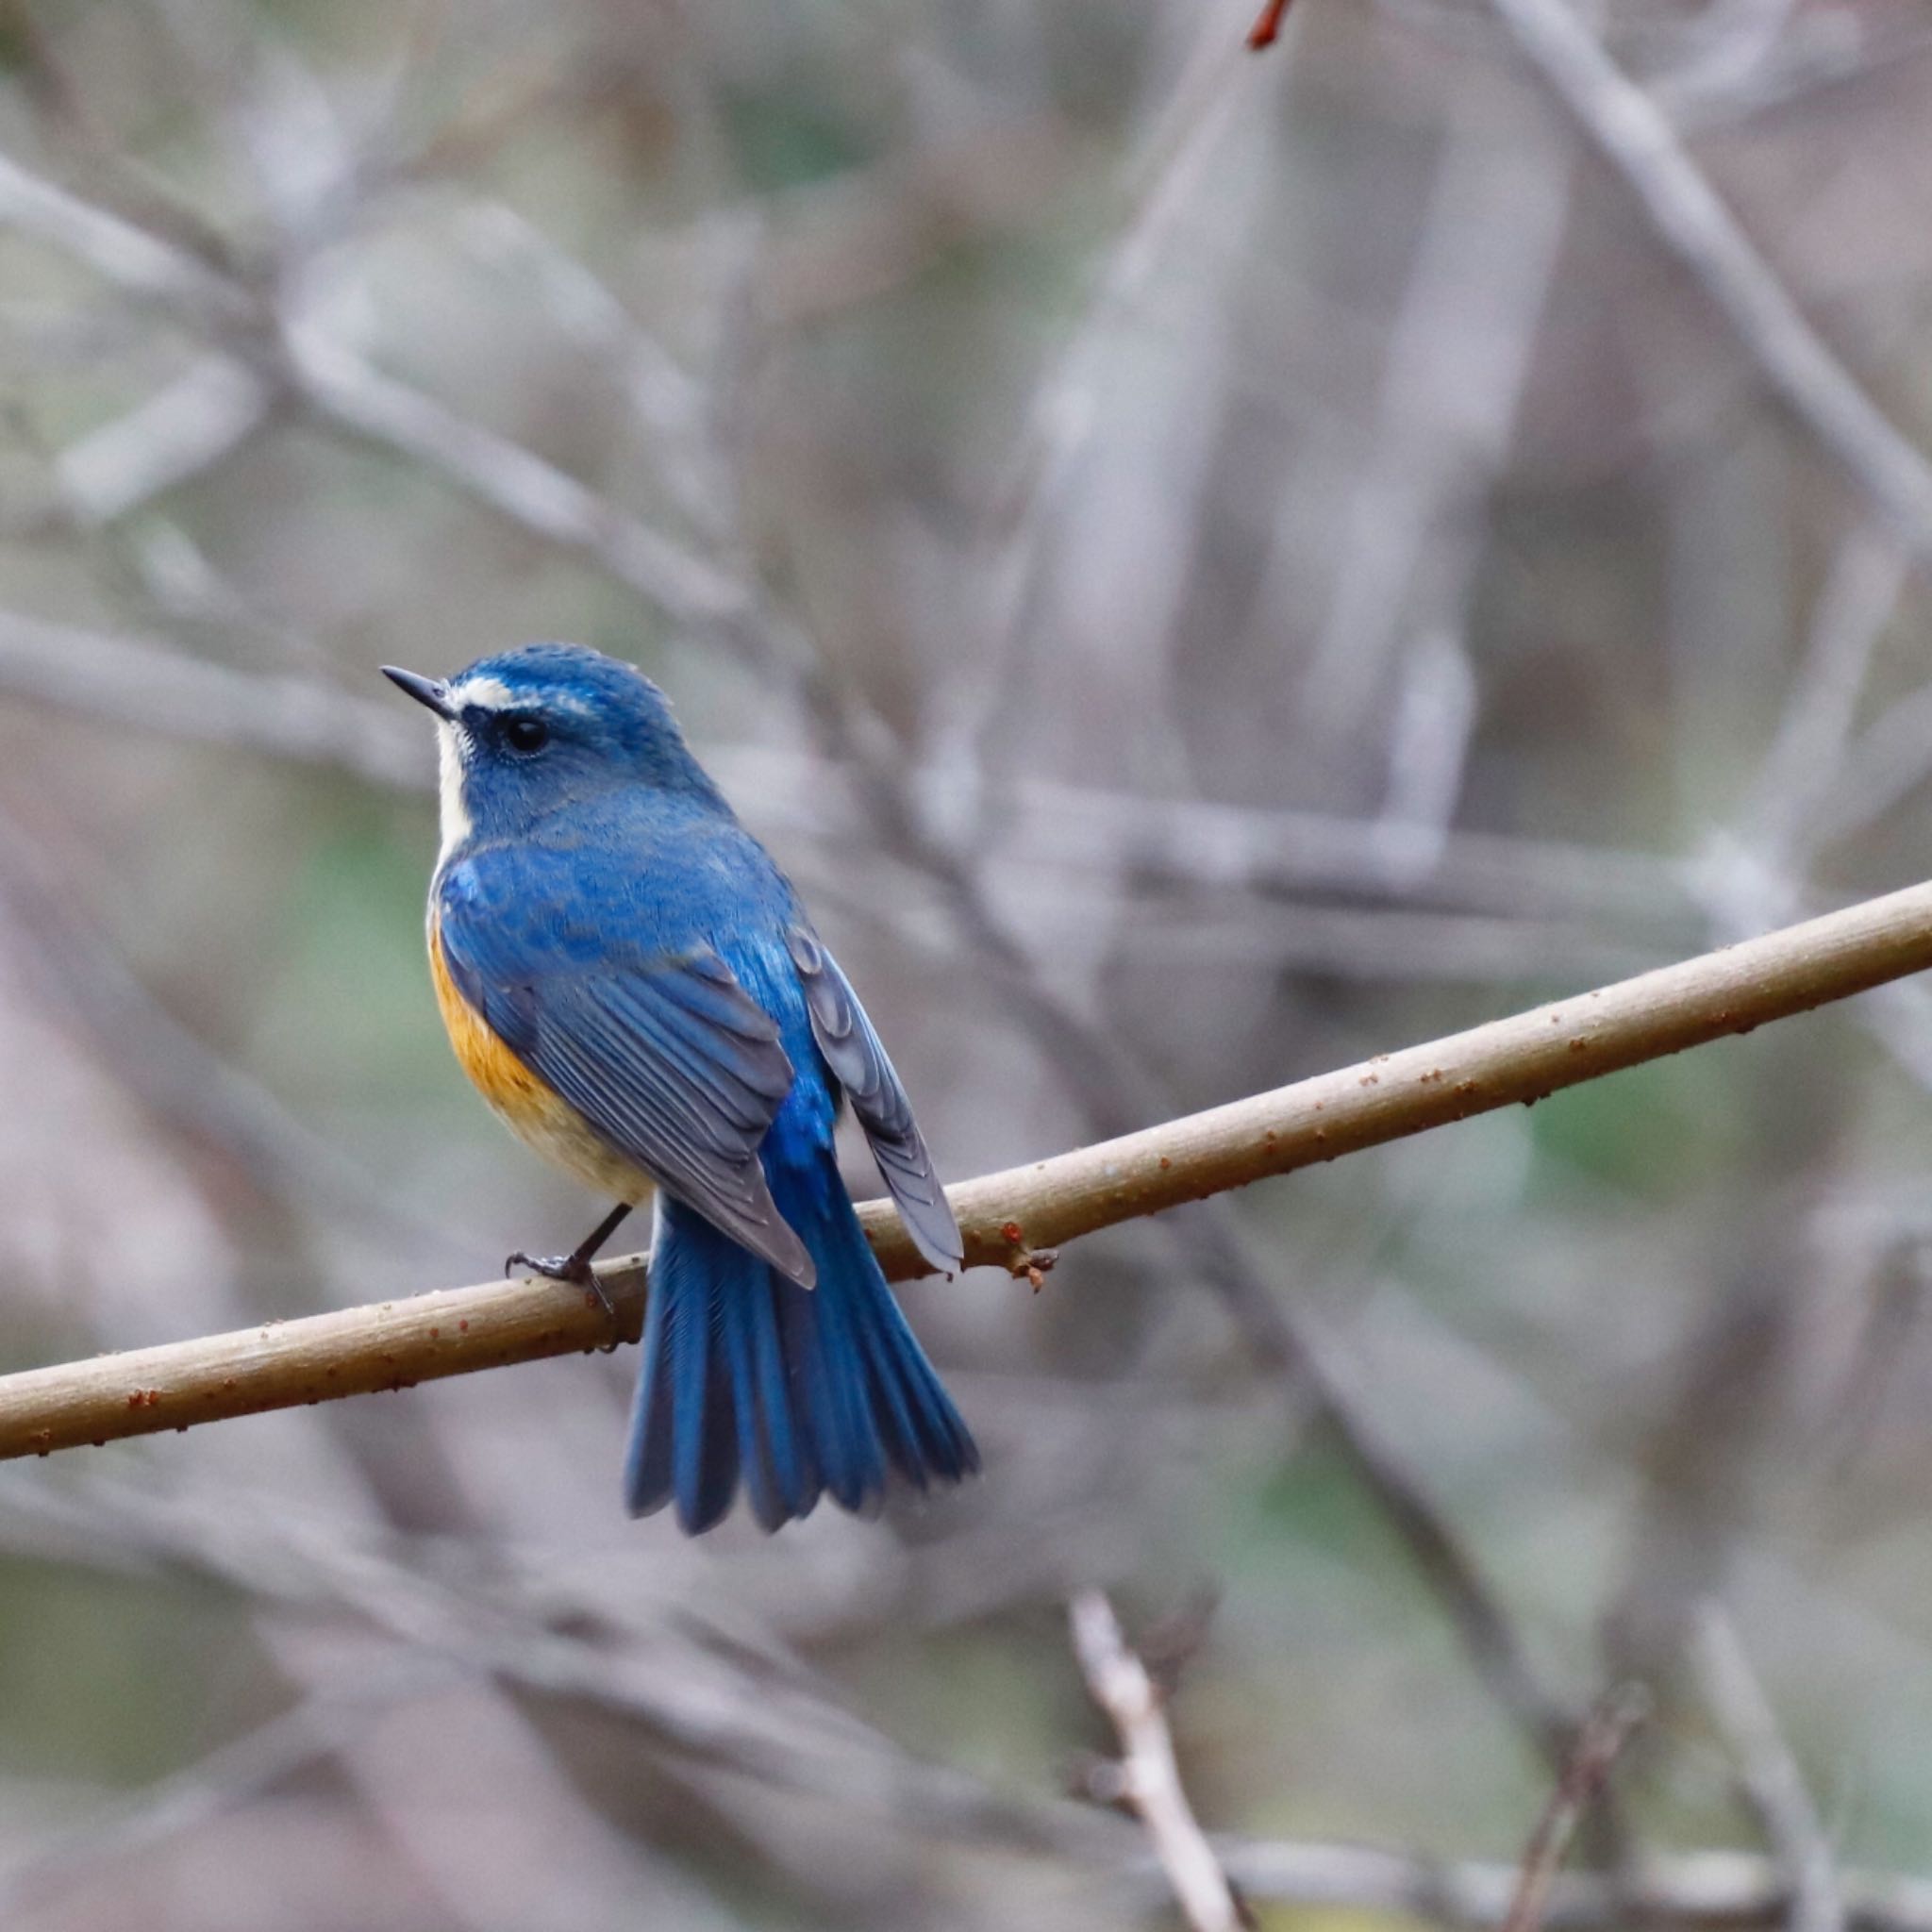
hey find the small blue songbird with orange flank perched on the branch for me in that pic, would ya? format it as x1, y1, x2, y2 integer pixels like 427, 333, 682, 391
385, 643, 979, 1534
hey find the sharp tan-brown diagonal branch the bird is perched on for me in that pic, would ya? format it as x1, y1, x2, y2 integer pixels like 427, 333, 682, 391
0, 869, 1932, 1458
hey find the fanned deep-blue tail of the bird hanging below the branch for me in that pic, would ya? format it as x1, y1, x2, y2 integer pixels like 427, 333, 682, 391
625, 1150, 979, 1536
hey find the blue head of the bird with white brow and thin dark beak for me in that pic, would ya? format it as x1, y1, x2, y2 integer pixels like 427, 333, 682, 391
383, 643, 717, 852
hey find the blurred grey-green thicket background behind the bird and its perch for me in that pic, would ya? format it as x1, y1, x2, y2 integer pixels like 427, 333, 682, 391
0, 0, 1932, 1932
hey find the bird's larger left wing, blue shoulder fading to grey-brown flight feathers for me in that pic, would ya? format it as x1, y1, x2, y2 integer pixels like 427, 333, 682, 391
439, 861, 815, 1289
